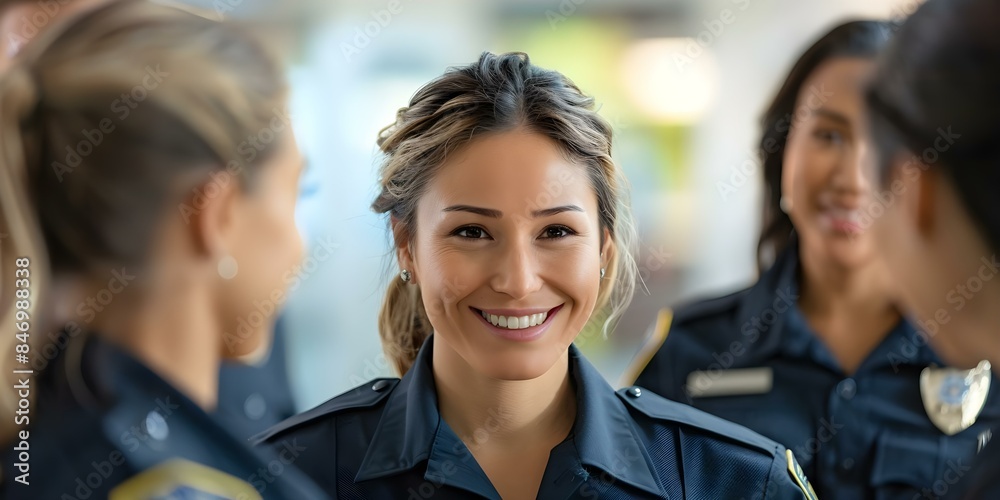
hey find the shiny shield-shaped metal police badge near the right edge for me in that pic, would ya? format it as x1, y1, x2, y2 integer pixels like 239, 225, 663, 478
920, 361, 991, 436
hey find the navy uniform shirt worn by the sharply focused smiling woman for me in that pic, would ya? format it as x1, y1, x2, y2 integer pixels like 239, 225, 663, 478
257, 336, 807, 500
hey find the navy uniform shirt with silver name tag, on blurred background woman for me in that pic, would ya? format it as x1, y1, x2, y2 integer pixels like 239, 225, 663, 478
636, 240, 1000, 500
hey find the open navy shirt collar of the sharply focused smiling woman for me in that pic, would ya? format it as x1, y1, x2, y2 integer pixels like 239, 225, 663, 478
355, 335, 663, 498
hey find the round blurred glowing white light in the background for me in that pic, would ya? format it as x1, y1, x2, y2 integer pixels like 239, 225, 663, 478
621, 38, 718, 125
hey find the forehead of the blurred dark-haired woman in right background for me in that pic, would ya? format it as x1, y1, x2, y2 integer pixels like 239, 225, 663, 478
797, 57, 874, 112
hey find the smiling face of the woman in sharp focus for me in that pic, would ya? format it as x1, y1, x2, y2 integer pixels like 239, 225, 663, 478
394, 127, 612, 381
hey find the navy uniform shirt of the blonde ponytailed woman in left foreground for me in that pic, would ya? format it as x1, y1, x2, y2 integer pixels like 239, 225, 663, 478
0, 332, 326, 500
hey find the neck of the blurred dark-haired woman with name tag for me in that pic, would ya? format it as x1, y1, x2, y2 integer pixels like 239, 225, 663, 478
799, 244, 901, 373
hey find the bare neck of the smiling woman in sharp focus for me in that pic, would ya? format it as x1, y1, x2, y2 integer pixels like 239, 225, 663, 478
433, 339, 576, 454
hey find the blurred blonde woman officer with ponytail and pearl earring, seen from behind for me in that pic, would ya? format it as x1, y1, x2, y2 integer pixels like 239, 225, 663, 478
0, 1, 324, 499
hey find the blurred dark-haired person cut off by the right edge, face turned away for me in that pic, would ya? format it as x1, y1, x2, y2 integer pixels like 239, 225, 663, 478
866, 0, 1000, 499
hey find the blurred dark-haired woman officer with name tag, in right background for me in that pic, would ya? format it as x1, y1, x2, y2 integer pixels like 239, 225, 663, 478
635, 21, 1000, 499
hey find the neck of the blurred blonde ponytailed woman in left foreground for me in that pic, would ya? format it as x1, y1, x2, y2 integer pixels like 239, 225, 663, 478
90, 278, 222, 412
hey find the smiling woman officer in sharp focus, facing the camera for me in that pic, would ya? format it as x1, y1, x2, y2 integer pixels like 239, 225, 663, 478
259, 53, 811, 499
